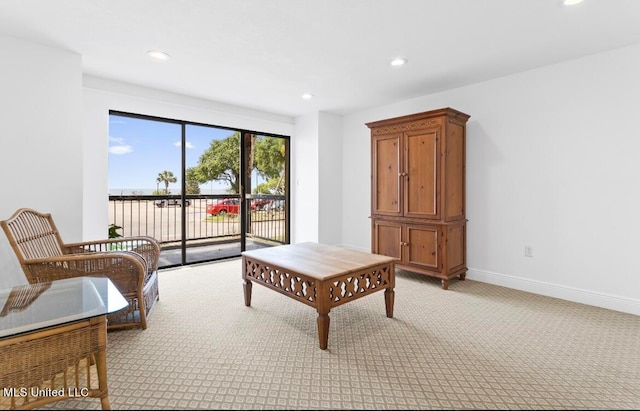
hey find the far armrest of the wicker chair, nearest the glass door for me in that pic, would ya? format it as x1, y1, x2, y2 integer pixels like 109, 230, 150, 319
63, 236, 160, 273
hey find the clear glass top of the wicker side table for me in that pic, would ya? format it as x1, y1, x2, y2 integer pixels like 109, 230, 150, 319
0, 277, 128, 338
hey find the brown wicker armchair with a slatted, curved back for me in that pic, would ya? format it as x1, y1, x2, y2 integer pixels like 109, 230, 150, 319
0, 208, 160, 330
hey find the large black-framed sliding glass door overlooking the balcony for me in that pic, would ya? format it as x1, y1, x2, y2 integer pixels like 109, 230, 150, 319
109, 112, 289, 267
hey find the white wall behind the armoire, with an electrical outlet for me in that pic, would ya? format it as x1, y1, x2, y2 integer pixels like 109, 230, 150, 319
342, 45, 640, 314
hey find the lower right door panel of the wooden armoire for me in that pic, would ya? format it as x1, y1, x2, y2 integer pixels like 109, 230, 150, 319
405, 226, 440, 270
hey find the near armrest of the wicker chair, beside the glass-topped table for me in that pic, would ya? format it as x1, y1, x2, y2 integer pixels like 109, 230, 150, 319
25, 251, 147, 297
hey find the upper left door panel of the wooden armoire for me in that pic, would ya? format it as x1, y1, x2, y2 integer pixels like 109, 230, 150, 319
372, 135, 402, 219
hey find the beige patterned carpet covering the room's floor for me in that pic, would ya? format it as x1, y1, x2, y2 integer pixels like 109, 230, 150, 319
46, 259, 640, 409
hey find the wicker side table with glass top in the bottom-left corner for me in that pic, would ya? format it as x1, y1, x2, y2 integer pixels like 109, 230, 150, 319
0, 277, 128, 410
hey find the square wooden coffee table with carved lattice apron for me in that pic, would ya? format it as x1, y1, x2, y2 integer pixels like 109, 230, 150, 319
242, 243, 395, 350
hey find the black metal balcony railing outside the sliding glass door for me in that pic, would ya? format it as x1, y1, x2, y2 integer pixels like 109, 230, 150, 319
109, 194, 287, 251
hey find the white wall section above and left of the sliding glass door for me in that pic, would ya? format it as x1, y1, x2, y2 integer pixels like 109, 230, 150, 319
83, 76, 294, 240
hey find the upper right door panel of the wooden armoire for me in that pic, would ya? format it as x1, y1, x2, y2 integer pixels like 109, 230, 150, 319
404, 128, 440, 219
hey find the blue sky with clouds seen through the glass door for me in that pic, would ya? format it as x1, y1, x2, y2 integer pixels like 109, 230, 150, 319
109, 115, 233, 195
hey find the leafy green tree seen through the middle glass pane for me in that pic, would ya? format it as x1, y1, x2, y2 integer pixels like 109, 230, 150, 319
194, 132, 240, 194
